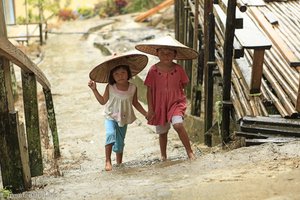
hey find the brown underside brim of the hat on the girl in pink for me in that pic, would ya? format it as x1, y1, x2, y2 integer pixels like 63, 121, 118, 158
135, 44, 198, 60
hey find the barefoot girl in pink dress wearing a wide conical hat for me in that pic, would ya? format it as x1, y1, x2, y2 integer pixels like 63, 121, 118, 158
136, 37, 198, 160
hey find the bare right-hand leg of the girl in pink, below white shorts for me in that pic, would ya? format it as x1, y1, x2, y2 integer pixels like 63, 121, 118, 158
173, 123, 196, 160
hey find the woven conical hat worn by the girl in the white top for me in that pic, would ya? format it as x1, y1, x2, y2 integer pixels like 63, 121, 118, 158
89, 52, 148, 83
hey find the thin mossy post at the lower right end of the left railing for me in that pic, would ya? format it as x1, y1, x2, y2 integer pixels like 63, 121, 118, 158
43, 88, 60, 158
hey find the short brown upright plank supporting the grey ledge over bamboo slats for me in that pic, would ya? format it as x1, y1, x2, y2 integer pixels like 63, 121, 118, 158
249, 49, 265, 94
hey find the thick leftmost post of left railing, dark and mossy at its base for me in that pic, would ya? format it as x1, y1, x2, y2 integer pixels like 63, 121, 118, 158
0, 0, 25, 193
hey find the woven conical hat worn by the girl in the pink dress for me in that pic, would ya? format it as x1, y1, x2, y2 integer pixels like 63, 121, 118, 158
135, 36, 198, 60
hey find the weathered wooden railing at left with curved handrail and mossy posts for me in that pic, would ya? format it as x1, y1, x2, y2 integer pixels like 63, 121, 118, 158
0, 1, 60, 193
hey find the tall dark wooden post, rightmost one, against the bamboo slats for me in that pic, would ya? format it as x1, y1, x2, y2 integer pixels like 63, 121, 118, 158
221, 0, 236, 144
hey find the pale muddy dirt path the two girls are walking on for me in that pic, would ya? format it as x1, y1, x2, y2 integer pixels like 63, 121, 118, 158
3, 16, 300, 200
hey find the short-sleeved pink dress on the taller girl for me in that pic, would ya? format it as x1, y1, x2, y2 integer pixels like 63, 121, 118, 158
144, 64, 189, 125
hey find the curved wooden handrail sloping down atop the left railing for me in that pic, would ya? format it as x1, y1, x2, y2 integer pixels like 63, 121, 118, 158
0, 37, 51, 89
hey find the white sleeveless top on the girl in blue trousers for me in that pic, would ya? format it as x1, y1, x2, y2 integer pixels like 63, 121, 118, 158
104, 83, 136, 127
